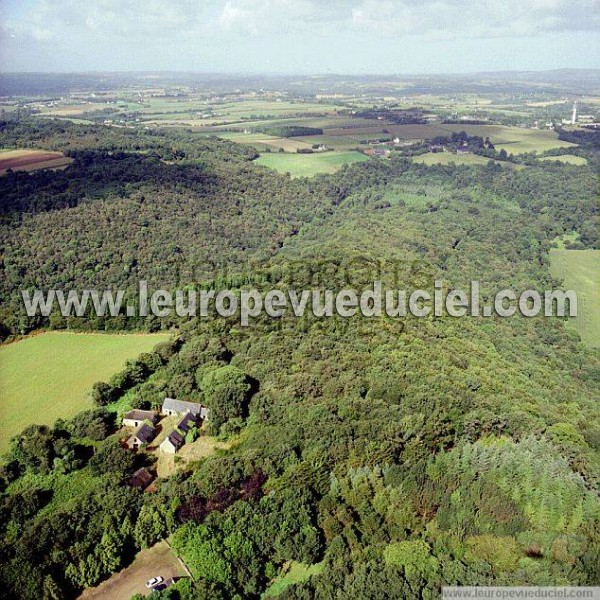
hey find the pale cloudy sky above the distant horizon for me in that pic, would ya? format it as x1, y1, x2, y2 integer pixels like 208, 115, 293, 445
0, 0, 600, 74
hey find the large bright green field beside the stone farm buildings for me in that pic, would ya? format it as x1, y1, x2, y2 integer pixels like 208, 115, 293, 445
0, 332, 169, 452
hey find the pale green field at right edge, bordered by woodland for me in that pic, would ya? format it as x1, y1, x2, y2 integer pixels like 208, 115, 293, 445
550, 249, 600, 348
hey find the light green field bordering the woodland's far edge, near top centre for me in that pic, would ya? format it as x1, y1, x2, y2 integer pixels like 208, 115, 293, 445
256, 152, 369, 177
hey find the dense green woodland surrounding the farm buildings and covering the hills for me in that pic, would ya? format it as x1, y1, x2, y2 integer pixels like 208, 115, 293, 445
0, 120, 600, 599
